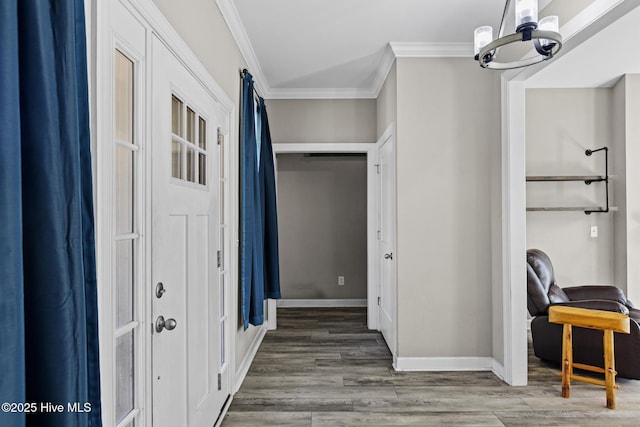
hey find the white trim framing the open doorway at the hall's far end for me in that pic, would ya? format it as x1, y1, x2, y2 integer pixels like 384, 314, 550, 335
268, 142, 378, 330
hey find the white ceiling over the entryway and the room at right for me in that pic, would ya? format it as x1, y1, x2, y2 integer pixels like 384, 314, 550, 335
216, 0, 640, 98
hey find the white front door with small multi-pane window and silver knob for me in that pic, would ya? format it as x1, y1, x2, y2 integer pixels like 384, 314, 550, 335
151, 38, 229, 427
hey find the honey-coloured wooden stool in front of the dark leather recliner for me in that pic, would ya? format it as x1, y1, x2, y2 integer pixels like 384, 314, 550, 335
549, 305, 629, 409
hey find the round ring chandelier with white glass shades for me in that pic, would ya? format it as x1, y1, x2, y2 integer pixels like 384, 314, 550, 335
473, 0, 562, 70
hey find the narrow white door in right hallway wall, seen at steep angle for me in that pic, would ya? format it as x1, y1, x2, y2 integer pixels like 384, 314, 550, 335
378, 135, 396, 360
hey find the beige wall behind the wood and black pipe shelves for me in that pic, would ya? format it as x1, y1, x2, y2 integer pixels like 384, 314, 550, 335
526, 89, 618, 287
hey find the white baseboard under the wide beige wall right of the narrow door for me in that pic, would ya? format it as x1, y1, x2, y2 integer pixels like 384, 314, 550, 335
393, 357, 496, 371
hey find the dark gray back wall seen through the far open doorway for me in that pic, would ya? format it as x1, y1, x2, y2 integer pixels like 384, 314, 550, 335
277, 154, 367, 299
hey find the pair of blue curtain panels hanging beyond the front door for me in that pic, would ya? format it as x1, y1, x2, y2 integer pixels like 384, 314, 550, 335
240, 71, 280, 329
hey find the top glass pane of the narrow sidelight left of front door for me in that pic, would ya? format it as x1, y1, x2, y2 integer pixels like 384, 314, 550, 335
115, 50, 133, 143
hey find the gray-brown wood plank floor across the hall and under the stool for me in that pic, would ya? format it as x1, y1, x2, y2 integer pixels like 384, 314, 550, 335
222, 308, 640, 427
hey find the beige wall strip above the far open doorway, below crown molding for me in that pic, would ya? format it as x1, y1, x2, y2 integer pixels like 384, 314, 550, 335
267, 99, 376, 143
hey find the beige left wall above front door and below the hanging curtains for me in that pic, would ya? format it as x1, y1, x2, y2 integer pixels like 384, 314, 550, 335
154, 0, 258, 368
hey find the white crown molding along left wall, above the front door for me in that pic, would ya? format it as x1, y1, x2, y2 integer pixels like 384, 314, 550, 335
216, 0, 270, 98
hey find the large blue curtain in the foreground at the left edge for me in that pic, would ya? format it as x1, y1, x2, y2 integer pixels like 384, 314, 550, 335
0, 0, 102, 427
